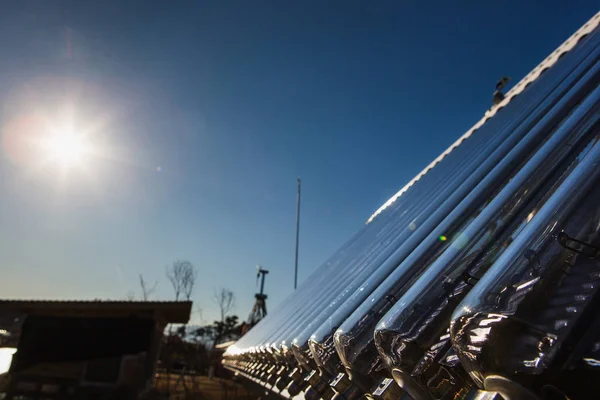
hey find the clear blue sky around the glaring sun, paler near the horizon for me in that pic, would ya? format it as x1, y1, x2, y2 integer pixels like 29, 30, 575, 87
0, 0, 597, 322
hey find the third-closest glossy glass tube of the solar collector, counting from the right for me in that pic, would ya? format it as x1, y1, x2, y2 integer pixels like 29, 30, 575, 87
336, 34, 600, 384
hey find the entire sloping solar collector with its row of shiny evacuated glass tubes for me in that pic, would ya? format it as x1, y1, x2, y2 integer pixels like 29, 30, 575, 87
223, 13, 600, 400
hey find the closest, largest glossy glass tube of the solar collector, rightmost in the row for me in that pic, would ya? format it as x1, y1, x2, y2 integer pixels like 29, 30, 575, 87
450, 134, 600, 397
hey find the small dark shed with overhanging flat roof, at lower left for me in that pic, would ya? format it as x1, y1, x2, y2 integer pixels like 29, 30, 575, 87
0, 300, 192, 399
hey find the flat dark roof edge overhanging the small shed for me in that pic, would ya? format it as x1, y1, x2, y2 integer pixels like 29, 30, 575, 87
0, 300, 192, 324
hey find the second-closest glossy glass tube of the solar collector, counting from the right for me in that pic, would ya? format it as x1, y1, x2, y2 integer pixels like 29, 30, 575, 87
375, 59, 600, 396
